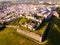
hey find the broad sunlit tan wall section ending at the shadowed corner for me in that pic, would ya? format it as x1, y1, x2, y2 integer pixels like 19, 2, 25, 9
17, 29, 41, 42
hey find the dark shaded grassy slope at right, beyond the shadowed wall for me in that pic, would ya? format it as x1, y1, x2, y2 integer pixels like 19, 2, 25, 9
47, 17, 60, 45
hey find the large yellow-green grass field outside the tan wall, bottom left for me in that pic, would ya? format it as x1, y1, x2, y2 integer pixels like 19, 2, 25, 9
0, 28, 38, 45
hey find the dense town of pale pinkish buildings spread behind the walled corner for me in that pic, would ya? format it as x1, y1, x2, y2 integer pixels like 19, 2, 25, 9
1, 4, 59, 28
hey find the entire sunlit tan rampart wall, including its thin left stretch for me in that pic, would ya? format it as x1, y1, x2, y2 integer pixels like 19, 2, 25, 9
6, 25, 41, 42
